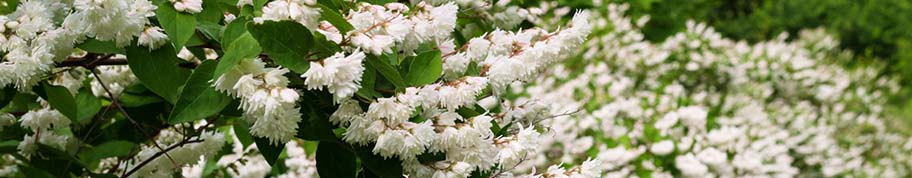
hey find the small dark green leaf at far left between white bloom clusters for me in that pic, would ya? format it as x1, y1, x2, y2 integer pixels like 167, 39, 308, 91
35, 83, 79, 121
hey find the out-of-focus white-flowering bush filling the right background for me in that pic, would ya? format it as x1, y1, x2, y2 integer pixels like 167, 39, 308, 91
512, 4, 912, 177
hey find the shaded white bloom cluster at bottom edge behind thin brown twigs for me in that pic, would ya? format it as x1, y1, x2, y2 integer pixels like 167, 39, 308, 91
124, 127, 225, 177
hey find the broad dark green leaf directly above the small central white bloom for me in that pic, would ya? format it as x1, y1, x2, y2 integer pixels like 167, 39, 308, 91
247, 21, 313, 73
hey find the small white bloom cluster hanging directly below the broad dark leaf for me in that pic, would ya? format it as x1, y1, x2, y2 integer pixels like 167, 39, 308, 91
301, 51, 365, 102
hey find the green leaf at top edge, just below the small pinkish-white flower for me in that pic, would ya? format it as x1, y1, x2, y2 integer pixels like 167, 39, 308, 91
155, 3, 196, 49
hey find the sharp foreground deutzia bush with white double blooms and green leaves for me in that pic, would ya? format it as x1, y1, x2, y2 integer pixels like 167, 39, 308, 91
0, 0, 603, 177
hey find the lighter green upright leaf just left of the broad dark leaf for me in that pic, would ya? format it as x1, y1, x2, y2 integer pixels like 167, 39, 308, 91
212, 33, 262, 79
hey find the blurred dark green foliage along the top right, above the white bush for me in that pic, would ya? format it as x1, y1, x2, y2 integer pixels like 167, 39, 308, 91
560, 0, 912, 123
